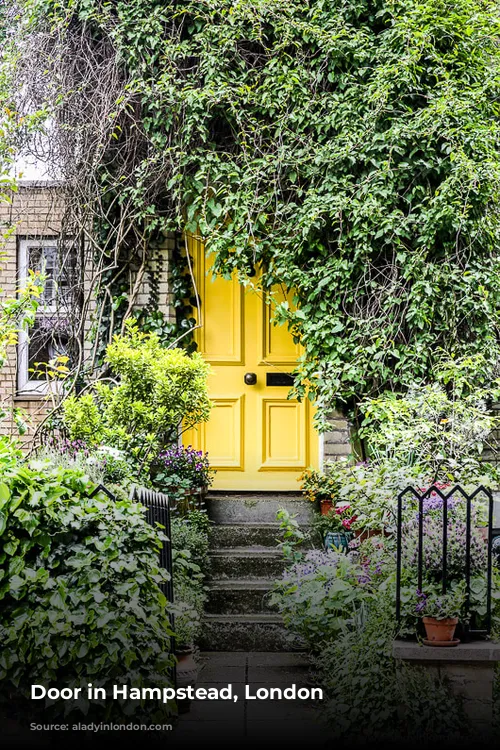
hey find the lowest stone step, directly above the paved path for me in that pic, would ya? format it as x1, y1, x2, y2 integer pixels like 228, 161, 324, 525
200, 614, 304, 652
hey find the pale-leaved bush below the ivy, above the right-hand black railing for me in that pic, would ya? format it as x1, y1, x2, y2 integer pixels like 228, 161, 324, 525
360, 355, 500, 472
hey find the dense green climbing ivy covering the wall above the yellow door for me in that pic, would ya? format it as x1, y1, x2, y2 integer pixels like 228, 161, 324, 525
8, 0, 500, 418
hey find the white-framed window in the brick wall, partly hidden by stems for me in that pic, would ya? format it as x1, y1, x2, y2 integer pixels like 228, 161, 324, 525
17, 238, 71, 395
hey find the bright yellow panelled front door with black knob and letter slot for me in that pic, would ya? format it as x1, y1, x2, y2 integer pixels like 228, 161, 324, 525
184, 237, 318, 491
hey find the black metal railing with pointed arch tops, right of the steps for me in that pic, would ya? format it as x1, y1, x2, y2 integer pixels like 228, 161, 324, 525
396, 485, 493, 637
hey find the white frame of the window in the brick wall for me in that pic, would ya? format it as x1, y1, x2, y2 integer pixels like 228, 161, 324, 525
17, 236, 67, 398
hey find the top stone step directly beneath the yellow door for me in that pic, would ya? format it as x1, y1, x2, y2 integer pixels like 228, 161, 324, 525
207, 492, 314, 525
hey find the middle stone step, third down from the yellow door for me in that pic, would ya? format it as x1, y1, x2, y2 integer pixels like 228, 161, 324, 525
210, 545, 285, 581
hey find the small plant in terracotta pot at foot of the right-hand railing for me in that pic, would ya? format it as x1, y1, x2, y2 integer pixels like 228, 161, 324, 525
415, 582, 465, 646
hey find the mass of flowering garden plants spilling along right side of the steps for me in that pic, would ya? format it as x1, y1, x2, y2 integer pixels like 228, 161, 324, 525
272, 358, 500, 742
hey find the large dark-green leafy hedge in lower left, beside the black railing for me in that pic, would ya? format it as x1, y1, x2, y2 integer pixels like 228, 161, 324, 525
0, 466, 173, 723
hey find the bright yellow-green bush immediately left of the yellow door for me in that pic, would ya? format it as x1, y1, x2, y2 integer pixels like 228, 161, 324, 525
62, 320, 210, 473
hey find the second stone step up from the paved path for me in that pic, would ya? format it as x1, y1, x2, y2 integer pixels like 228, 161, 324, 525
205, 579, 280, 615
